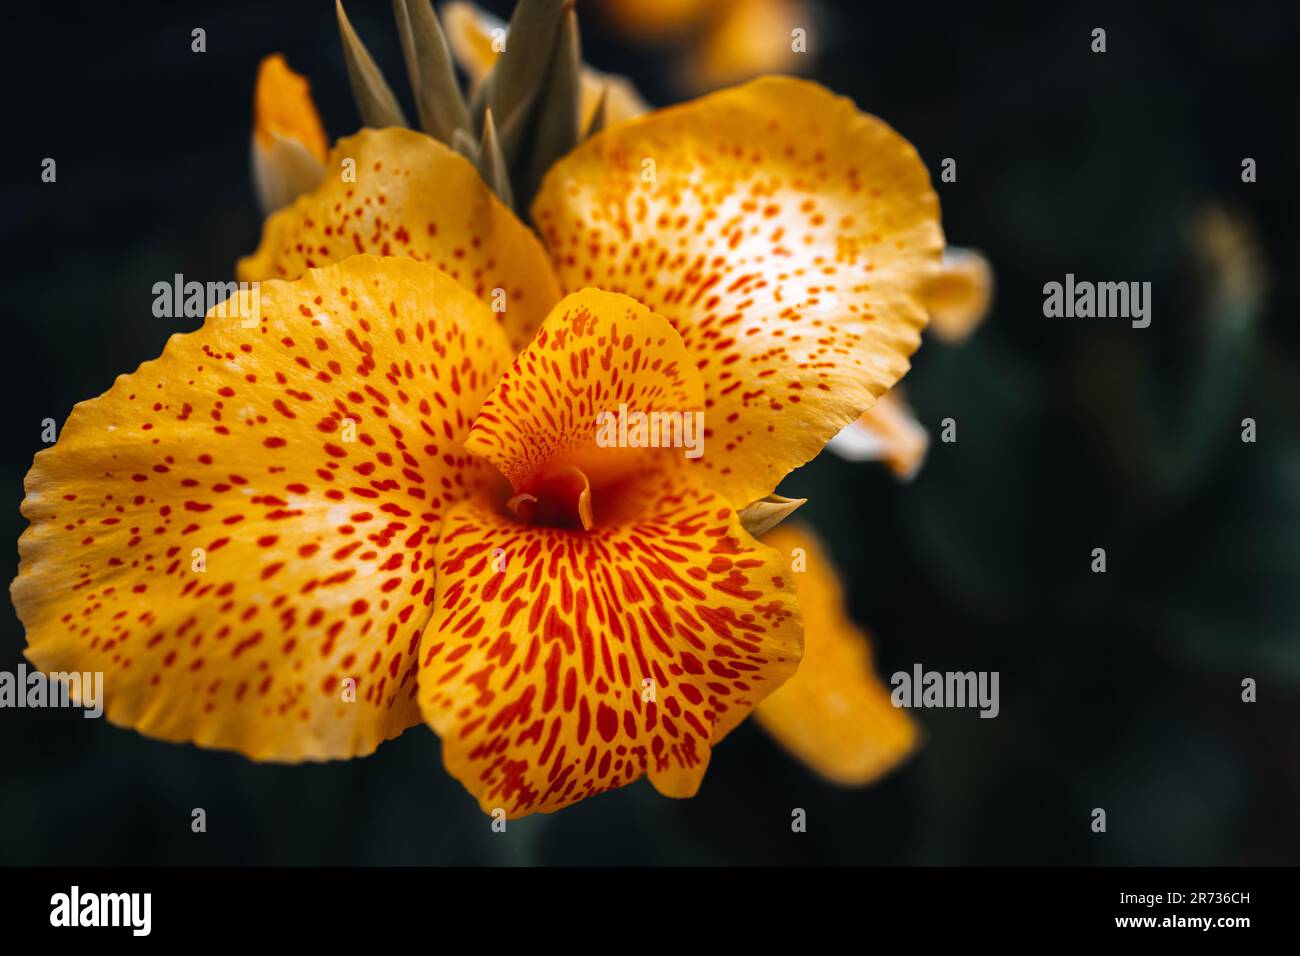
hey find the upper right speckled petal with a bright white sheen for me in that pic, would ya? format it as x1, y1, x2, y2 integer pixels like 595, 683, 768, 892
533, 77, 943, 507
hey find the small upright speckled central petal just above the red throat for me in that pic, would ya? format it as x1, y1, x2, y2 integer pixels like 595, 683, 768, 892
465, 289, 703, 494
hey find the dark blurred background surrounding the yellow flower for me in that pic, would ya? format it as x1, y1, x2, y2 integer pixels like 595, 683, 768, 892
0, 0, 1300, 864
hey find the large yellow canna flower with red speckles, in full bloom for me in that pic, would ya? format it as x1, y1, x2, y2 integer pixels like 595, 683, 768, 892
12, 1, 943, 818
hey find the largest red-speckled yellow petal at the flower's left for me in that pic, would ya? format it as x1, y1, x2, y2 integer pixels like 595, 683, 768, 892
13, 256, 508, 761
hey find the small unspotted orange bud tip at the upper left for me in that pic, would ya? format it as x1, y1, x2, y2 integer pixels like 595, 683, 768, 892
252, 53, 328, 213
